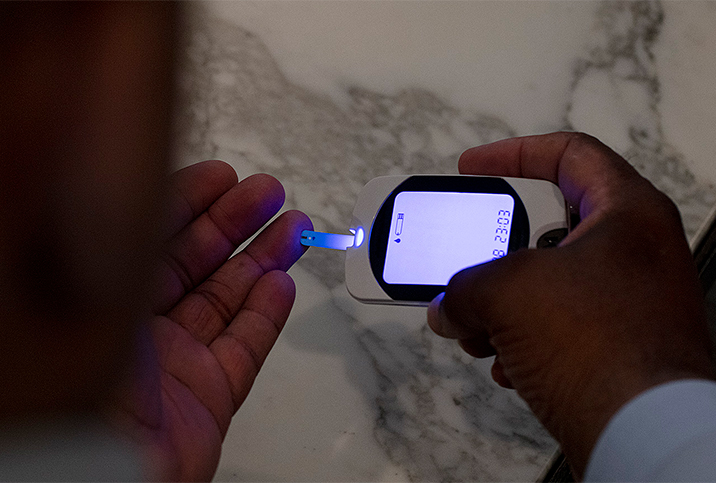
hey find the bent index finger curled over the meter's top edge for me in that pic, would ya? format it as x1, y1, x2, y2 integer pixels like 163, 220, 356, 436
458, 132, 643, 223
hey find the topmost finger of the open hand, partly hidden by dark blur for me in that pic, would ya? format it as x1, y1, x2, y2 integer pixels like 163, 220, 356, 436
168, 160, 239, 236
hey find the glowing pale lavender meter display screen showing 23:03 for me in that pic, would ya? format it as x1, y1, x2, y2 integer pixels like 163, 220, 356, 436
383, 191, 515, 285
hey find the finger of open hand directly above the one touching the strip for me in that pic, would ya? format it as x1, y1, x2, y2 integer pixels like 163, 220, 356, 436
154, 174, 284, 314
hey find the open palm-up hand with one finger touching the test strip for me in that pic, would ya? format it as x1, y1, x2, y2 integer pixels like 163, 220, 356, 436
110, 161, 311, 481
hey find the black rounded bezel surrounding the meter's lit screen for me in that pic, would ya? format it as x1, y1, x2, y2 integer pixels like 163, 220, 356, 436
368, 175, 530, 302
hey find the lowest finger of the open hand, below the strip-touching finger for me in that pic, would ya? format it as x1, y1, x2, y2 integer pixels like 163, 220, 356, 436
209, 271, 295, 410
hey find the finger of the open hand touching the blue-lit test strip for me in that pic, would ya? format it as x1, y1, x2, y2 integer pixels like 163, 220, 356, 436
167, 211, 312, 344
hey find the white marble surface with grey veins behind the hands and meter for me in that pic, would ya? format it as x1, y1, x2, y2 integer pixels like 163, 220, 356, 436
173, 0, 716, 481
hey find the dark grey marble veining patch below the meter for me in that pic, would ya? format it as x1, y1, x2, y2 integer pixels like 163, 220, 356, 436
350, 326, 554, 481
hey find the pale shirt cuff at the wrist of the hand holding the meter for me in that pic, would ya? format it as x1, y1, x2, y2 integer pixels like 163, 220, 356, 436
584, 380, 716, 481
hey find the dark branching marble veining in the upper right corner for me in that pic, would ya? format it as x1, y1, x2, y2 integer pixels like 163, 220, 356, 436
565, 2, 716, 233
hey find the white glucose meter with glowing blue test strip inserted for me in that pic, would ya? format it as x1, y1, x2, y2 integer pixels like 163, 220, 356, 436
301, 175, 570, 305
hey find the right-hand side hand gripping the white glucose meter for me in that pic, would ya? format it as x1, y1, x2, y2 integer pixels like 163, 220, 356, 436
428, 133, 713, 474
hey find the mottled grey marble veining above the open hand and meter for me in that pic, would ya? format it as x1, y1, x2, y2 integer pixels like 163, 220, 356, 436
174, 8, 515, 286
